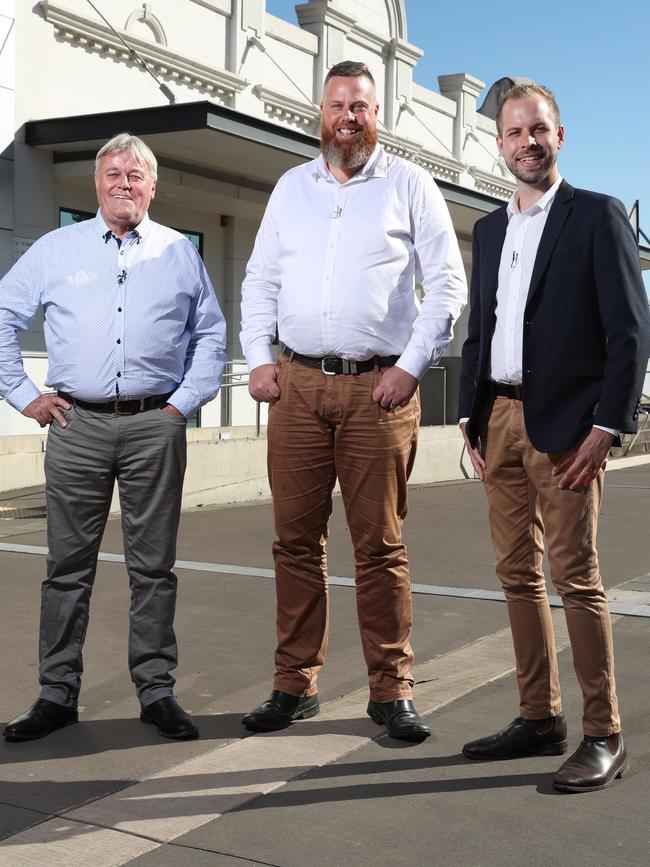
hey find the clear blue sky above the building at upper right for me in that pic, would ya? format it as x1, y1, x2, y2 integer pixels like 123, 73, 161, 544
266, 0, 650, 288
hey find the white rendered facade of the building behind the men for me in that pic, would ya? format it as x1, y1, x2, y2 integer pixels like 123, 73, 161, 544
0, 0, 509, 433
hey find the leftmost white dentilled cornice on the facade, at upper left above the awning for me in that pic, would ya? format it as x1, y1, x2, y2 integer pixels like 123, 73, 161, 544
40, 0, 248, 101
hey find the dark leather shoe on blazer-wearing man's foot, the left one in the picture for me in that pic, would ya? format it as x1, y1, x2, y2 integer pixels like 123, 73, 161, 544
463, 713, 567, 759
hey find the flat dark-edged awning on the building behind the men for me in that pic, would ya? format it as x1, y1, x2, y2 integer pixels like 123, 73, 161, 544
25, 101, 502, 227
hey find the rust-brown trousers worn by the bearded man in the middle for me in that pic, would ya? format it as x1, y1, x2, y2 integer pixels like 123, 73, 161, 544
268, 355, 420, 701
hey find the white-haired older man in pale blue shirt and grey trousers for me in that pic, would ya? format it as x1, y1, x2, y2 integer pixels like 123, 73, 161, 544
0, 133, 225, 741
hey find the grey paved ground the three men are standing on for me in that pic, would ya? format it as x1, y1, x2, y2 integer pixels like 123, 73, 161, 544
0, 458, 650, 867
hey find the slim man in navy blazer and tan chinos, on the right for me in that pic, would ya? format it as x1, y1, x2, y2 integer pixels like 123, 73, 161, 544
460, 85, 650, 792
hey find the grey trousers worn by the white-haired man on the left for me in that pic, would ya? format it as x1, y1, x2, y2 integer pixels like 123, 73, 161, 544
39, 407, 186, 707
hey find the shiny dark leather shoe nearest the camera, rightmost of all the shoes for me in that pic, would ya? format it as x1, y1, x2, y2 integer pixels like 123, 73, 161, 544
553, 734, 630, 792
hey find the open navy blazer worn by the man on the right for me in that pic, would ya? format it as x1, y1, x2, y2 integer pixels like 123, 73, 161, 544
459, 181, 650, 452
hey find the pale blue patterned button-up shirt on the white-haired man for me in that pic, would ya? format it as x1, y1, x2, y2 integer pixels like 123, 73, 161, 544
0, 212, 226, 416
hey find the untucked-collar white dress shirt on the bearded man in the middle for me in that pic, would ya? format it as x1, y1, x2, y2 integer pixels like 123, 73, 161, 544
241, 145, 467, 379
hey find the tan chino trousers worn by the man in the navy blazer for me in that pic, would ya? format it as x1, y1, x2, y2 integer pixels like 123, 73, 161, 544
481, 397, 620, 736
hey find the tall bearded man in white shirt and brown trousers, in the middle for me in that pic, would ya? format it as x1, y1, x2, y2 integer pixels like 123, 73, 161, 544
241, 61, 467, 742
